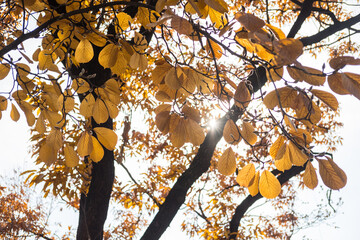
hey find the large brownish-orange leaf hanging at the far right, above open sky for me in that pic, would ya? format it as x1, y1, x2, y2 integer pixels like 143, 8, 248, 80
317, 158, 347, 190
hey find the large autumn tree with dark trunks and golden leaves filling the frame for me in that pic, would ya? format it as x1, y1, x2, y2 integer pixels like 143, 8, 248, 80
0, 0, 360, 239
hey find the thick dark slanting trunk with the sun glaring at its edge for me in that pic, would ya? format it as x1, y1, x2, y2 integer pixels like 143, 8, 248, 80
141, 67, 267, 240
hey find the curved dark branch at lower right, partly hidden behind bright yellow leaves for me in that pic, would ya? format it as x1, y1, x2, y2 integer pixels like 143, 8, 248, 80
229, 164, 306, 240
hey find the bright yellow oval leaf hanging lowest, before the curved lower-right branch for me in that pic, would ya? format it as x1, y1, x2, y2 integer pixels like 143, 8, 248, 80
259, 170, 281, 199
